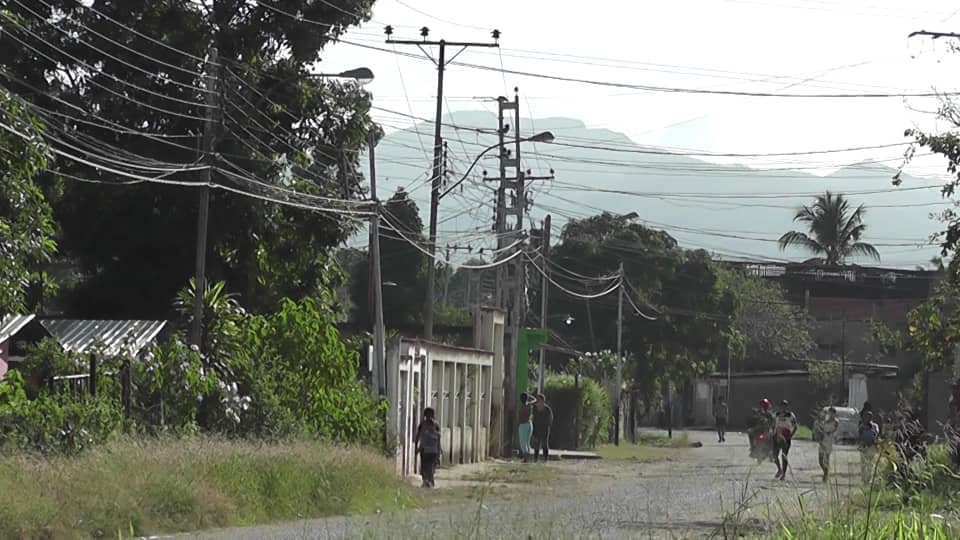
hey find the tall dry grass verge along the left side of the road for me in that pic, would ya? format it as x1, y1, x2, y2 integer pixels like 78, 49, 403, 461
0, 438, 419, 539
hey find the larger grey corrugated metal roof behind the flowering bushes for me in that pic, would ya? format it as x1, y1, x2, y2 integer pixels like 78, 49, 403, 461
40, 319, 167, 356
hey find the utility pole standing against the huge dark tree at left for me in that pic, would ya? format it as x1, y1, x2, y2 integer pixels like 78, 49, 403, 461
190, 43, 220, 349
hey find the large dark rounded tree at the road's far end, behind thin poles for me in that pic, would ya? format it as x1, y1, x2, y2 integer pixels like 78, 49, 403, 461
548, 213, 736, 396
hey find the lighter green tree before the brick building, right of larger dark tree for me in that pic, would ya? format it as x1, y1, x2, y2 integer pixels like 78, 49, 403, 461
718, 267, 815, 367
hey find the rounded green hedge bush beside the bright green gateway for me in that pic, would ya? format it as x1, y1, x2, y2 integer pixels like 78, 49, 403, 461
543, 375, 613, 448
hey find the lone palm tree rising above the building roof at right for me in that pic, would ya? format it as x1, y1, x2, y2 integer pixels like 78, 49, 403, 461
779, 191, 880, 266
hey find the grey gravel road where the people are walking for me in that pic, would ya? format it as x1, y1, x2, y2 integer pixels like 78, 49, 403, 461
172, 432, 859, 540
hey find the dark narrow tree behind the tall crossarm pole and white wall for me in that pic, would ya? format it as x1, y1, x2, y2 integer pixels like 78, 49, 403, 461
350, 188, 427, 327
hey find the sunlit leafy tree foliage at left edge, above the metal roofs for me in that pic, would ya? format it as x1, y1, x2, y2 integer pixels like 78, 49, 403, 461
0, 89, 57, 317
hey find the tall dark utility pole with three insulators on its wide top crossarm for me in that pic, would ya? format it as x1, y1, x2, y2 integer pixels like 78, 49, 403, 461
384, 26, 500, 341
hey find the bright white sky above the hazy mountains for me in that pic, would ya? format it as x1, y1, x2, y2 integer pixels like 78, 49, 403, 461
321, 0, 960, 266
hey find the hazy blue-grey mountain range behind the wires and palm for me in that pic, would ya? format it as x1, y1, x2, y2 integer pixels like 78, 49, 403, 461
364, 111, 944, 268
